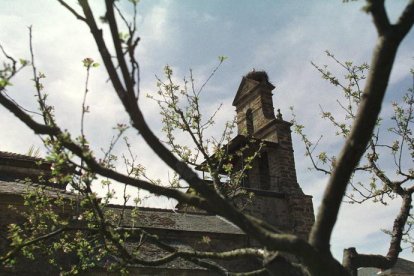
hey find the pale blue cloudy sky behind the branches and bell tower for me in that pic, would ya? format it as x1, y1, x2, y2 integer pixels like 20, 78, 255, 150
0, 0, 414, 260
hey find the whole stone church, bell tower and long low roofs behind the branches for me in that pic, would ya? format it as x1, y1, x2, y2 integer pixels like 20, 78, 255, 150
0, 71, 314, 275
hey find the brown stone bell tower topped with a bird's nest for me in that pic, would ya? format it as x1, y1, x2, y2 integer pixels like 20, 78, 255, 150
233, 71, 314, 238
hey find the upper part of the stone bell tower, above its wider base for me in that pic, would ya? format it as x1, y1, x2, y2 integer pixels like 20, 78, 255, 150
233, 71, 301, 192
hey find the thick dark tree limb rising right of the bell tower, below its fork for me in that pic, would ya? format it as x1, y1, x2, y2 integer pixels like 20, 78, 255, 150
310, 1, 414, 254
